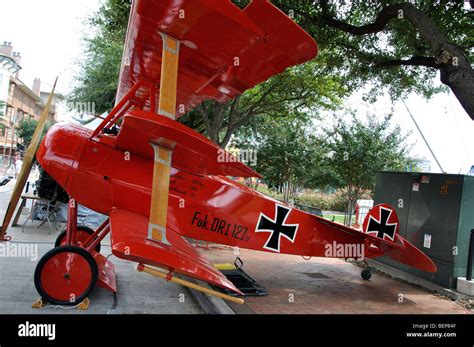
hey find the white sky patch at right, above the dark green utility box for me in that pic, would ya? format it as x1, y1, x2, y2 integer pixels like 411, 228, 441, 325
345, 86, 474, 174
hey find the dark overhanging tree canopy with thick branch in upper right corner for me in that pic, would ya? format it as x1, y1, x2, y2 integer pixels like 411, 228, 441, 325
275, 0, 474, 119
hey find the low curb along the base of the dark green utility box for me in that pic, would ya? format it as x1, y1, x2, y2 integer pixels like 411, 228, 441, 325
368, 259, 470, 301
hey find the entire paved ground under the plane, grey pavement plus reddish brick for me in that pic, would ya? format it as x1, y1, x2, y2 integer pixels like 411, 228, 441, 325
0, 181, 472, 314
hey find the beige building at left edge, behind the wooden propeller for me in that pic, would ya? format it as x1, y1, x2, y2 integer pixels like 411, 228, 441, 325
0, 42, 56, 168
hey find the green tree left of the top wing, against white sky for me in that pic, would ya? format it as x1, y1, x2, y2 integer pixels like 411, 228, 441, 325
67, 0, 131, 114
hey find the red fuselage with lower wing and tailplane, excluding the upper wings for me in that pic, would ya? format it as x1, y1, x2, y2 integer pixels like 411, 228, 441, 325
37, 119, 434, 285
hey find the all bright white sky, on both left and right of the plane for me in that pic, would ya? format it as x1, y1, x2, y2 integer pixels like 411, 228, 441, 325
0, 0, 474, 173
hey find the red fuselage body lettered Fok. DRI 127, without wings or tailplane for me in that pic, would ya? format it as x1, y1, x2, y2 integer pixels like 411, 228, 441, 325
37, 123, 368, 256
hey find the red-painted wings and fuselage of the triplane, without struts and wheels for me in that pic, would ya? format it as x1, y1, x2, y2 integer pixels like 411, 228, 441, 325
33, 0, 436, 291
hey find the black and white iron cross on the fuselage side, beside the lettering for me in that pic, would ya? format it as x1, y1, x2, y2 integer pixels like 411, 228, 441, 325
255, 205, 299, 252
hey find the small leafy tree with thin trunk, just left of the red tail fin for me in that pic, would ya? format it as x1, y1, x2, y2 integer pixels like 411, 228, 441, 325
321, 116, 416, 226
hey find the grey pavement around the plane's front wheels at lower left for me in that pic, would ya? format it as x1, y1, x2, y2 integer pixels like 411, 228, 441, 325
0, 182, 202, 314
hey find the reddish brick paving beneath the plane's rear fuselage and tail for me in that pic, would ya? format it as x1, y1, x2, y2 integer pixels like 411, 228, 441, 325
203, 249, 473, 314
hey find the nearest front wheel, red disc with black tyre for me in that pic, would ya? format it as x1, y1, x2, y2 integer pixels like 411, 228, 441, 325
35, 246, 98, 305
